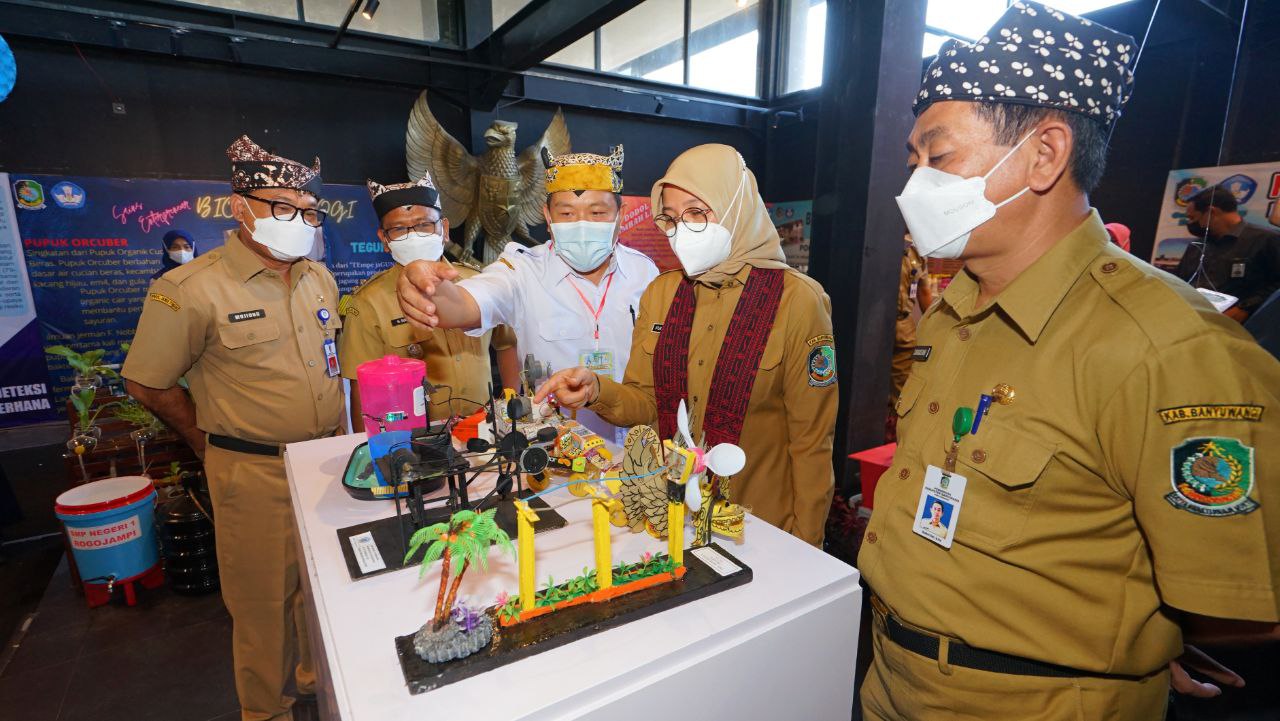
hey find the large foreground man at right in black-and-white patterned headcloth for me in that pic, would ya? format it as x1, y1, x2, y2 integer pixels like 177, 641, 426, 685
858, 1, 1280, 720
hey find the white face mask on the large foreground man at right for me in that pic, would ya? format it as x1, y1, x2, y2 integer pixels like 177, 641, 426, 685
897, 131, 1036, 259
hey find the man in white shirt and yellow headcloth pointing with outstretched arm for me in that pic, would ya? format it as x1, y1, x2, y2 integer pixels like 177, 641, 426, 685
398, 146, 658, 443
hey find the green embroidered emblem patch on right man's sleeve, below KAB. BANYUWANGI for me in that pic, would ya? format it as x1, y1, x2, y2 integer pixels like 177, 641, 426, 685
1165, 438, 1258, 516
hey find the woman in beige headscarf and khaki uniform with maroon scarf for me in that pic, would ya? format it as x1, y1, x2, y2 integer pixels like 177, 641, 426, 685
538, 145, 838, 544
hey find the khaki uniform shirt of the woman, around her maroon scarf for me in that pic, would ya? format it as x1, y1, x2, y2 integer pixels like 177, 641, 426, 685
591, 266, 840, 544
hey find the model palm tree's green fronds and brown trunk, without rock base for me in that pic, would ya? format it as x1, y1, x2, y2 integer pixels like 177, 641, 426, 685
404, 508, 516, 630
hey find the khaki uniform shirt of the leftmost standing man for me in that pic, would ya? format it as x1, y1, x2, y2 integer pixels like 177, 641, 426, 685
122, 238, 343, 443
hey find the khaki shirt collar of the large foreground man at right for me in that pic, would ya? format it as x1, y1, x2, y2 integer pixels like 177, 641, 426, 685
942, 210, 1110, 343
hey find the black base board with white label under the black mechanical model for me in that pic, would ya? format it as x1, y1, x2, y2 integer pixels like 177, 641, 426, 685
338, 490, 568, 581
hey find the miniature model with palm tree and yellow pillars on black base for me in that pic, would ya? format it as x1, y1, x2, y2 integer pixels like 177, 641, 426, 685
397, 406, 751, 693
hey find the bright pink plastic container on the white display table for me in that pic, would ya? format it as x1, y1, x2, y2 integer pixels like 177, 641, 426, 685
356, 356, 428, 435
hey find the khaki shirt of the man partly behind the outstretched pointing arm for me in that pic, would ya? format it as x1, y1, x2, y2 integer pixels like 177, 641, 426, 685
338, 265, 515, 420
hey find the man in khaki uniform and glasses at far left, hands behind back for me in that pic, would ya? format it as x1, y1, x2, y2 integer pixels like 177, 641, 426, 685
122, 137, 343, 721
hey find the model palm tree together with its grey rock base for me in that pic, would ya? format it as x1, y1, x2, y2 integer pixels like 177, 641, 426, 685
404, 508, 516, 663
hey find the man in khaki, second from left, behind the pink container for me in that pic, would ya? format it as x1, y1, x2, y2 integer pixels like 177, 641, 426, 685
338, 175, 518, 432
